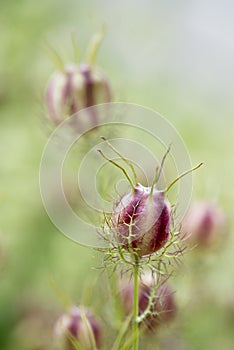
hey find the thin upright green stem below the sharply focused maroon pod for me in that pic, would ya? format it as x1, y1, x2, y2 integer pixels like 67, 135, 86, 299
133, 257, 139, 350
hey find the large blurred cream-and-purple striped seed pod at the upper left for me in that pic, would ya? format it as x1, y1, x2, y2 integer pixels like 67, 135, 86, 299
45, 64, 111, 125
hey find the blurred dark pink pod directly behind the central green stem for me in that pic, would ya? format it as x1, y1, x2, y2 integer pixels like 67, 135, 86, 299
120, 273, 176, 330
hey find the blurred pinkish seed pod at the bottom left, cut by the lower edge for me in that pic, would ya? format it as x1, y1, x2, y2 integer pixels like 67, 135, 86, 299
55, 306, 102, 350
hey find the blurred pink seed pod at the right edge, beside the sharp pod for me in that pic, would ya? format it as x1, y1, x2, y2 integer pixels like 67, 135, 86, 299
182, 202, 226, 247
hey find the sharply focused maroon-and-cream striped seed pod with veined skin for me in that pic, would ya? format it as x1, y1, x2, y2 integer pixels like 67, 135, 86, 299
112, 183, 170, 257
